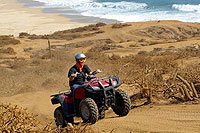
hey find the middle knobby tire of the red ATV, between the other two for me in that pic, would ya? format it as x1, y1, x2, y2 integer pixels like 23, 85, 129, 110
79, 98, 99, 124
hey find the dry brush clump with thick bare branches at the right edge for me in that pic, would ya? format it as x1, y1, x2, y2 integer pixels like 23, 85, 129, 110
160, 64, 200, 103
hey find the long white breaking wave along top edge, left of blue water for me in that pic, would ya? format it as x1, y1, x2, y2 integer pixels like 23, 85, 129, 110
31, 0, 147, 12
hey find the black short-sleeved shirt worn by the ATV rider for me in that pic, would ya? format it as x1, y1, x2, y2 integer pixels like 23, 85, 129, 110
68, 65, 91, 86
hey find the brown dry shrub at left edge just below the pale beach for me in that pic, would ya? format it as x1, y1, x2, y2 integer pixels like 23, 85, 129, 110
0, 36, 20, 47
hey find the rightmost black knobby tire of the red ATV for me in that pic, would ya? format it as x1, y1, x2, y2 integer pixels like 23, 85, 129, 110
112, 89, 131, 116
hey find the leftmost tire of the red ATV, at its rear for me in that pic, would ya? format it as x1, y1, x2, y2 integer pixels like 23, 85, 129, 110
54, 106, 66, 127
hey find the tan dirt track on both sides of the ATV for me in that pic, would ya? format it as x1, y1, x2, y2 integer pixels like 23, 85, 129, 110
0, 90, 200, 133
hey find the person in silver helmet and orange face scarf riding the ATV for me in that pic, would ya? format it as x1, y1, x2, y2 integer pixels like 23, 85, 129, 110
68, 53, 101, 92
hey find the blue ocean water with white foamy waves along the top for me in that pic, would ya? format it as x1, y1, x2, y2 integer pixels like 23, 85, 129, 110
19, 0, 200, 22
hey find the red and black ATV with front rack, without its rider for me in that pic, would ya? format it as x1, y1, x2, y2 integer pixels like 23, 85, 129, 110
51, 72, 131, 127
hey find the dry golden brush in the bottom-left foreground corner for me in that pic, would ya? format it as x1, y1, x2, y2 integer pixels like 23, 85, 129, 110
0, 104, 94, 133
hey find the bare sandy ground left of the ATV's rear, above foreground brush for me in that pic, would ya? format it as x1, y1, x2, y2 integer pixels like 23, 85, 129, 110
0, 91, 57, 120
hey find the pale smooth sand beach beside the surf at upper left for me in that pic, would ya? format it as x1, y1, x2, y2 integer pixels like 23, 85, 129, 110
0, 0, 86, 36
